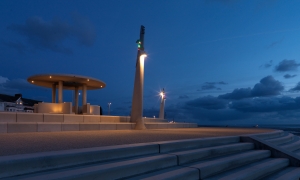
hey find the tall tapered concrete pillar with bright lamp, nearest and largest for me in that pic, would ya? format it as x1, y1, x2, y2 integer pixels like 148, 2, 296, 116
131, 26, 146, 130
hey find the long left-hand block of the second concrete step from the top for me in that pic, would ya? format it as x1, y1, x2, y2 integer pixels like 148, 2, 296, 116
11, 154, 177, 180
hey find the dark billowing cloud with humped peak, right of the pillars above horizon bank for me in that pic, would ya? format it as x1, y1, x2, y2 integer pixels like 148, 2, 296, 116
218, 76, 284, 100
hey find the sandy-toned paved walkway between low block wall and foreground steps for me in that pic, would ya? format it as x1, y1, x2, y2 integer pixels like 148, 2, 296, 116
0, 127, 273, 156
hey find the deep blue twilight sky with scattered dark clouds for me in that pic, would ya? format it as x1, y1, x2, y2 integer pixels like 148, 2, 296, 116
0, 0, 300, 125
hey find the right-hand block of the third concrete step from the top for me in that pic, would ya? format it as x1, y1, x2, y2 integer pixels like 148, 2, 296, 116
185, 150, 271, 179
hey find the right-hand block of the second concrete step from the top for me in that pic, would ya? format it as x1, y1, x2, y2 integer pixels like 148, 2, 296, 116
170, 143, 254, 165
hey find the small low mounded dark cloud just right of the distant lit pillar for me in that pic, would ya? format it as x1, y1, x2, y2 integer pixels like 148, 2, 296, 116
186, 96, 227, 109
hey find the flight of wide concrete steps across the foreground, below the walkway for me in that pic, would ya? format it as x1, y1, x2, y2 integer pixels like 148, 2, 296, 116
0, 131, 300, 180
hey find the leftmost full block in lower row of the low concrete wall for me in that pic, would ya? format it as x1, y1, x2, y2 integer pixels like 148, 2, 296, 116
7, 122, 37, 133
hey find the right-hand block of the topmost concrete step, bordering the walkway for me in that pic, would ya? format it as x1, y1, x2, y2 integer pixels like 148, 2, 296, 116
158, 136, 240, 153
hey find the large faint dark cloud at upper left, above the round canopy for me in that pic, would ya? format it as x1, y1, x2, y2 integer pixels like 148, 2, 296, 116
7, 13, 96, 54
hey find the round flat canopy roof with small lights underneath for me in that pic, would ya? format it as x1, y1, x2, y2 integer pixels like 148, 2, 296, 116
27, 74, 106, 90
